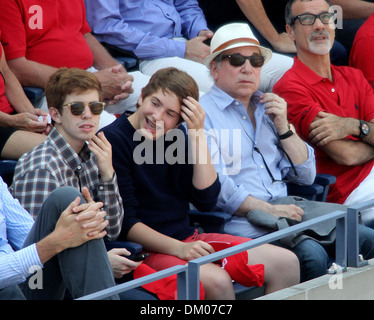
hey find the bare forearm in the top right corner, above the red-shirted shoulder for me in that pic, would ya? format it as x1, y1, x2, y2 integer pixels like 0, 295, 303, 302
330, 0, 374, 19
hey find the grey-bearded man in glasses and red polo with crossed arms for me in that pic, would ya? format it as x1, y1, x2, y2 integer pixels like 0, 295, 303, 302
274, 0, 374, 223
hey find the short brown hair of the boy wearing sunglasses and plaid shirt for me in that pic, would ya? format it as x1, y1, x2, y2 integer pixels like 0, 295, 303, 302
45, 68, 102, 113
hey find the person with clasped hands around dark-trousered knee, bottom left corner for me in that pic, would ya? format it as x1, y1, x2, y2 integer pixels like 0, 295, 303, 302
0, 179, 118, 300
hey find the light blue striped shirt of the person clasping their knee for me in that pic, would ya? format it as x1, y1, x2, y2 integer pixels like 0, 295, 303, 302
0, 178, 42, 289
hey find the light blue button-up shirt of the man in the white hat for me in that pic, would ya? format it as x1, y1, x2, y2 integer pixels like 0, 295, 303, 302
200, 85, 316, 218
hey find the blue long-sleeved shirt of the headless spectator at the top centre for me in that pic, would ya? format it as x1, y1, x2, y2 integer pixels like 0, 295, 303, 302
85, 0, 208, 60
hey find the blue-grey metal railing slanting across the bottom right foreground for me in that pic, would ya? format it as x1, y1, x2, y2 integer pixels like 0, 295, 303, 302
78, 209, 350, 300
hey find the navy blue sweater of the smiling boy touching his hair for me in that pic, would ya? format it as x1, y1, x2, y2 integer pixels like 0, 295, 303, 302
102, 115, 221, 240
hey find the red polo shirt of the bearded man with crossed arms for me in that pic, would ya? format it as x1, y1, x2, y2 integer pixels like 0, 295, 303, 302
273, 58, 374, 203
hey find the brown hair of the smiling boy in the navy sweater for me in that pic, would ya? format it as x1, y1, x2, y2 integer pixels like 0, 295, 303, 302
142, 67, 199, 104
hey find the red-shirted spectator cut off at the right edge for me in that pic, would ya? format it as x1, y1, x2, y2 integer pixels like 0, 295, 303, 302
349, 13, 374, 87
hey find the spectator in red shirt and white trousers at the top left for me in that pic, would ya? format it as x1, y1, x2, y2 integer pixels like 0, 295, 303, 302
0, 0, 148, 127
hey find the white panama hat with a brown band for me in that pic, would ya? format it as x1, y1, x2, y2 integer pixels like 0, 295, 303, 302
203, 23, 272, 68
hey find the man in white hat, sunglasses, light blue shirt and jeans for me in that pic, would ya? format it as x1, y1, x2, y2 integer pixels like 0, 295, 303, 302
200, 24, 374, 281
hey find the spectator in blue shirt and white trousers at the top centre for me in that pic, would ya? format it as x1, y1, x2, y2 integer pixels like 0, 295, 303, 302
86, 0, 292, 93
